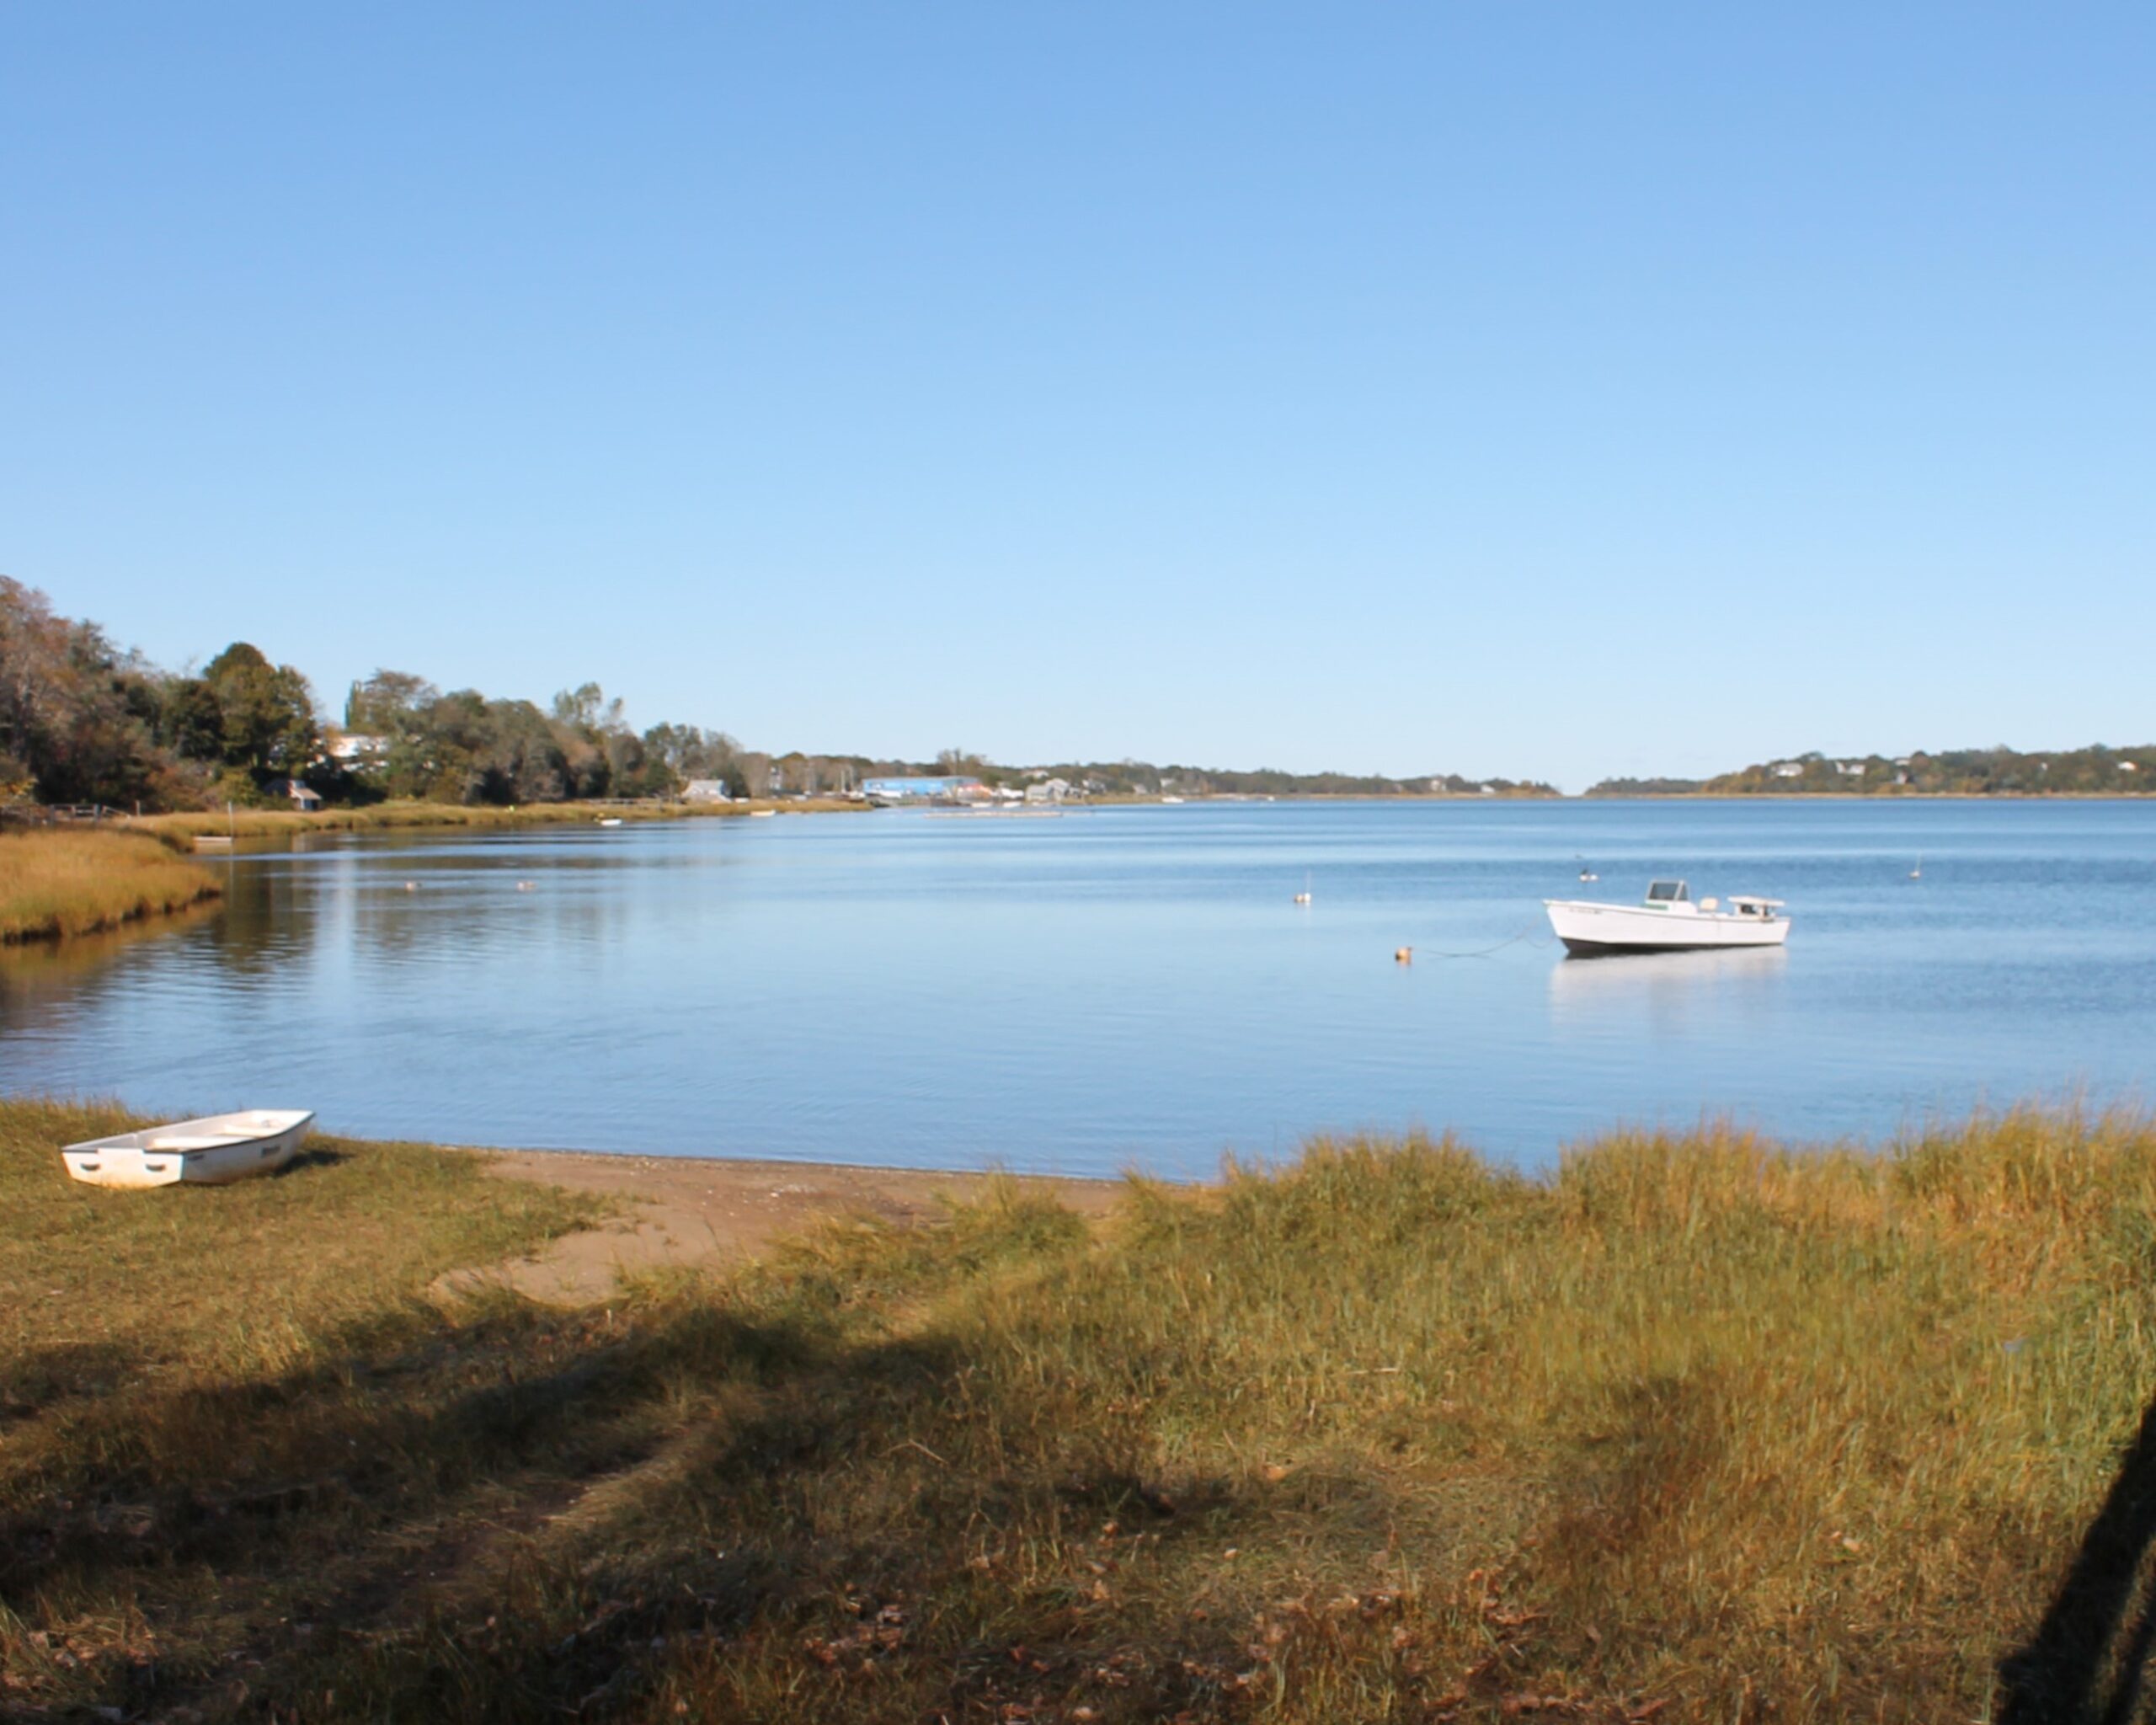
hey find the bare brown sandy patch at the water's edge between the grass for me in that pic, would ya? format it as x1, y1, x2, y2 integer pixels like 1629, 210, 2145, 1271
453, 1149, 1121, 1305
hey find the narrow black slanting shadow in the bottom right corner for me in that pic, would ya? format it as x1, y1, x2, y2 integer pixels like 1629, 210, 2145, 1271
1999, 1399, 2156, 1725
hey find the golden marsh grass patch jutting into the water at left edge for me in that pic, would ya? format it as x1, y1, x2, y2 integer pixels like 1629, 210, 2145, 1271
0, 828, 224, 943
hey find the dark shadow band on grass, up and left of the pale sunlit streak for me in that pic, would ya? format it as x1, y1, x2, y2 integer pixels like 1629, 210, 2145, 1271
0, 1306, 862, 1718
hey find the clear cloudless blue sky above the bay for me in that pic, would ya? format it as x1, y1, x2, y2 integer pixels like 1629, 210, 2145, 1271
0, 0, 2156, 787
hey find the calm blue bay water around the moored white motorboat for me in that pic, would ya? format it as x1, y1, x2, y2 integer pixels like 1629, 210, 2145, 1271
0, 802, 2156, 1178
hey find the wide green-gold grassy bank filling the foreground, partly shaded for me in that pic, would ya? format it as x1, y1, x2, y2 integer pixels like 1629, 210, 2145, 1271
0, 1104, 2156, 1722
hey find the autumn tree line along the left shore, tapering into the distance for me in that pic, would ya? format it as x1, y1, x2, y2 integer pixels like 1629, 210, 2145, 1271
0, 576, 1555, 811
